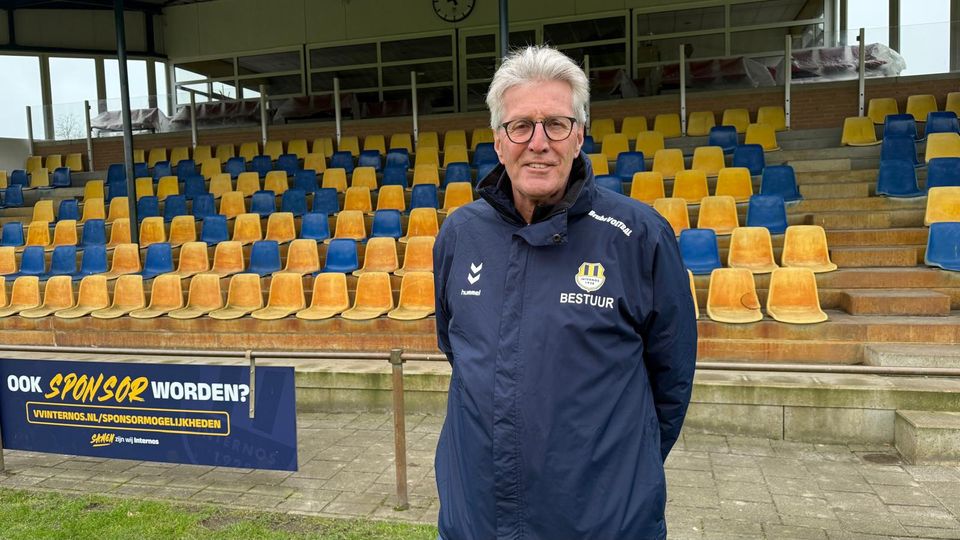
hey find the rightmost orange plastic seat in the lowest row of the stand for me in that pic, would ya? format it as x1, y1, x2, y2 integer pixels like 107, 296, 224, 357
767, 268, 827, 324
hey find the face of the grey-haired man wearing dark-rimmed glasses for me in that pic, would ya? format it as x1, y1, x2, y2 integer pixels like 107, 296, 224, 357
494, 81, 583, 209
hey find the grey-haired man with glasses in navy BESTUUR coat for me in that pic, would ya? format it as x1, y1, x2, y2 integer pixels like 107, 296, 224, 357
434, 46, 697, 540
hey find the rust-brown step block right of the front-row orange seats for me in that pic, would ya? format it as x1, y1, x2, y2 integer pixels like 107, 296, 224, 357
841, 289, 950, 317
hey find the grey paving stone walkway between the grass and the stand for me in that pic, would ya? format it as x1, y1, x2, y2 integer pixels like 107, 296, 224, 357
0, 413, 960, 540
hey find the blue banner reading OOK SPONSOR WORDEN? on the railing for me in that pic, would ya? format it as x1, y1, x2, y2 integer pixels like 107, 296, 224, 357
0, 359, 297, 471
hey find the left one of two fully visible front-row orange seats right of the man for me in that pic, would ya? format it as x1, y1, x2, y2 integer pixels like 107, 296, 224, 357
707, 268, 763, 324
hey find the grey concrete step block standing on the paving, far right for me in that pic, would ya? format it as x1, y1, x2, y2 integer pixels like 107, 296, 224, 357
894, 410, 960, 464
